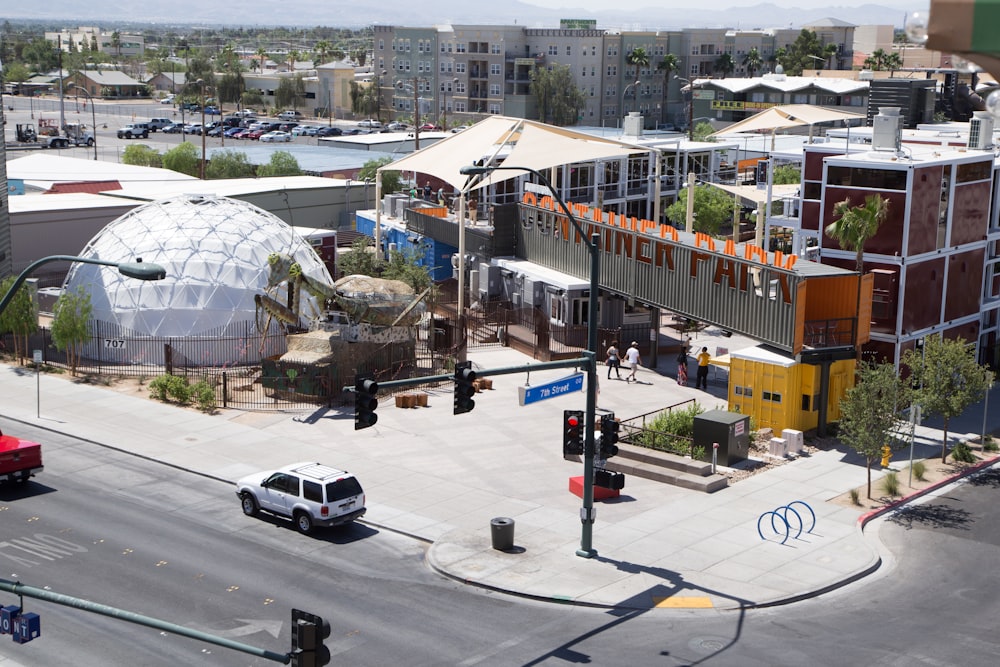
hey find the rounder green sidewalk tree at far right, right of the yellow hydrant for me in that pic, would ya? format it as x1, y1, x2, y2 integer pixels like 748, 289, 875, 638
901, 334, 993, 463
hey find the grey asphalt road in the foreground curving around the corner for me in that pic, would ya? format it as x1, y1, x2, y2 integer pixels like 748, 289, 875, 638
0, 427, 1000, 667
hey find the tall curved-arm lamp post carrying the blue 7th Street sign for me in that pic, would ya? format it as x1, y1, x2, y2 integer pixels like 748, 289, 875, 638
459, 165, 601, 558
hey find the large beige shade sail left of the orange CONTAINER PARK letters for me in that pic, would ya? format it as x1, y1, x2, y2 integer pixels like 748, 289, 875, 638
382, 116, 650, 189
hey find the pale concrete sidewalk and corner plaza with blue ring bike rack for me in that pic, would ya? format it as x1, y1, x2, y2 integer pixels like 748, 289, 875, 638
0, 348, 981, 609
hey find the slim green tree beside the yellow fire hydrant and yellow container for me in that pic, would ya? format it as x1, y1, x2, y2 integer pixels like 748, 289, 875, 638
837, 363, 907, 498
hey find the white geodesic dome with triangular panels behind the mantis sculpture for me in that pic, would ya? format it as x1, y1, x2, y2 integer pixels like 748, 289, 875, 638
65, 195, 333, 338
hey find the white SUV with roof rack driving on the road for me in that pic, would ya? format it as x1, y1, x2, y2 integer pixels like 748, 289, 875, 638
236, 463, 365, 533
